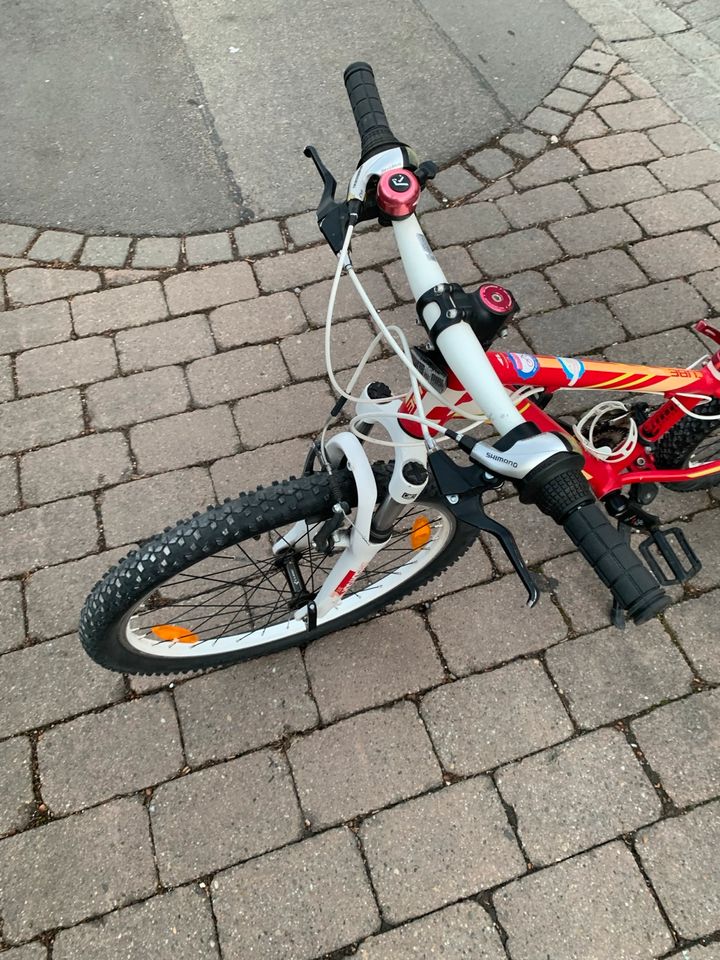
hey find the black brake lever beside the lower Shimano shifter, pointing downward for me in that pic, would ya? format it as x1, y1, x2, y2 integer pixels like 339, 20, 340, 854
428, 450, 540, 607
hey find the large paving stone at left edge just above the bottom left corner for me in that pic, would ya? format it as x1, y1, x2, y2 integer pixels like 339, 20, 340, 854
0, 799, 155, 943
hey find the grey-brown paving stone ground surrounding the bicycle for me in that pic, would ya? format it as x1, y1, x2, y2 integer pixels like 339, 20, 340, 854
0, 37, 720, 960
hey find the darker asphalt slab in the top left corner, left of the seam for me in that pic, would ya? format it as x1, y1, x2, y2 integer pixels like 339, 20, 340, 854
0, 0, 242, 234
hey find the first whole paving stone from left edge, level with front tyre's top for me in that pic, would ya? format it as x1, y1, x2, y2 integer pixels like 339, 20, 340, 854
20, 433, 132, 504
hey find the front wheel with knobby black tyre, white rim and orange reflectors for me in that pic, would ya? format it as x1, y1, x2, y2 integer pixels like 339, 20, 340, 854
80, 464, 475, 673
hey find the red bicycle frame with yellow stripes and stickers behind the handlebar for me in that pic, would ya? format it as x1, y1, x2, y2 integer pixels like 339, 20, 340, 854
399, 334, 720, 498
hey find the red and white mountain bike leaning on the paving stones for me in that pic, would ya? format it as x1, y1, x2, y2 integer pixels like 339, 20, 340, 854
80, 63, 720, 673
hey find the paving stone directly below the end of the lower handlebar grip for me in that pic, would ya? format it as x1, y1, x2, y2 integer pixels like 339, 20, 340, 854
547, 622, 692, 727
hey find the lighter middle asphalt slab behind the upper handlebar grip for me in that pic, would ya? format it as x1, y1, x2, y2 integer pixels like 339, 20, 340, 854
170, 0, 510, 218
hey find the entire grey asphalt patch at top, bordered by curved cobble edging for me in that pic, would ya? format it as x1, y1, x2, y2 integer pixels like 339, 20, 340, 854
0, 0, 593, 234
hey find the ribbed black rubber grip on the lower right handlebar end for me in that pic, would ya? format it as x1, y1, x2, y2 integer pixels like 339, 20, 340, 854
563, 503, 671, 624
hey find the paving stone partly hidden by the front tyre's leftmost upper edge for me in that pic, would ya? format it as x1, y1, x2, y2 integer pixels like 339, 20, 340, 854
25, 550, 124, 640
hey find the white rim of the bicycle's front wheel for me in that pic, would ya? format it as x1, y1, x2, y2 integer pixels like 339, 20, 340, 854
122, 504, 455, 660
